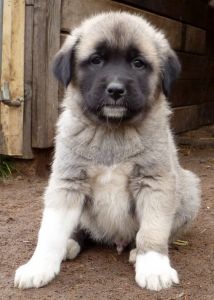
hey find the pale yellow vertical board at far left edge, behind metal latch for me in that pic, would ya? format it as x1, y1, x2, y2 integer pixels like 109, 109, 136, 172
0, 0, 25, 156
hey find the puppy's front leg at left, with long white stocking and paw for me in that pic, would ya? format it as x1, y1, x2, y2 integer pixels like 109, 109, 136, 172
14, 188, 84, 289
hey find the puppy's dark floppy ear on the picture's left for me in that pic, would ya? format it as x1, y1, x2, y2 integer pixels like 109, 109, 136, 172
53, 34, 79, 87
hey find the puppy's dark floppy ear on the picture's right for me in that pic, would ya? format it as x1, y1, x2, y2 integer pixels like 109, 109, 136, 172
161, 50, 181, 97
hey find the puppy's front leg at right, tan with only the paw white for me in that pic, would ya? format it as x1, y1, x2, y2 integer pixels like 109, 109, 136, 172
135, 177, 179, 291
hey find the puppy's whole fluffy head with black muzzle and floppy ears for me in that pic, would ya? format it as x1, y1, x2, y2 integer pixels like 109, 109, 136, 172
54, 12, 180, 122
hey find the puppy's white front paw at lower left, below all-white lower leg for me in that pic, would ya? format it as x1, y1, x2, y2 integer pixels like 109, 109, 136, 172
14, 259, 60, 289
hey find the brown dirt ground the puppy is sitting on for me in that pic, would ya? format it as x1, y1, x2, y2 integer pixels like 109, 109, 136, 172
0, 147, 214, 300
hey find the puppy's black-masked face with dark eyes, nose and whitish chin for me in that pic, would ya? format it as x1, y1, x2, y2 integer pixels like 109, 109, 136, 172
78, 40, 153, 122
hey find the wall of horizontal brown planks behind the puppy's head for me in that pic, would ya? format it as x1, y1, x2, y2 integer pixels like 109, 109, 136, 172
59, 0, 214, 132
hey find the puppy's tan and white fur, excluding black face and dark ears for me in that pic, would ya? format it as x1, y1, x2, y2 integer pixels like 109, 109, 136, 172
15, 12, 200, 290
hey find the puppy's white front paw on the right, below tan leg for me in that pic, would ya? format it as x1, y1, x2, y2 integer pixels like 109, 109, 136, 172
135, 251, 179, 291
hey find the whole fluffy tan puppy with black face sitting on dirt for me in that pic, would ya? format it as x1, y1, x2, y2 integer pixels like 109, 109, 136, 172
15, 12, 200, 291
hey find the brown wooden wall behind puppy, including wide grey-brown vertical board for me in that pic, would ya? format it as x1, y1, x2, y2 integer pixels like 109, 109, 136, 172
26, 0, 214, 148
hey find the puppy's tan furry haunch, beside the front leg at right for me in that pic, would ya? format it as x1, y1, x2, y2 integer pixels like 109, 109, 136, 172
170, 169, 201, 242
